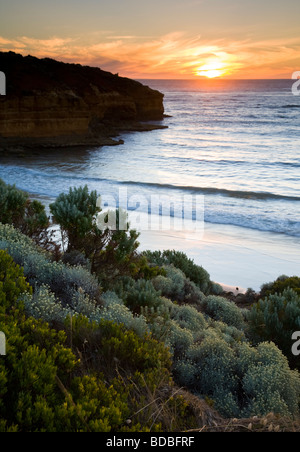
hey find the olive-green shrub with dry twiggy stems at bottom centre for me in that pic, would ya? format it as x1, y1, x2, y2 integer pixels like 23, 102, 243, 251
64, 317, 197, 432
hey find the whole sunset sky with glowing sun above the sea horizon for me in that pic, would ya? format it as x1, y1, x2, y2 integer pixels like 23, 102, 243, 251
0, 0, 300, 79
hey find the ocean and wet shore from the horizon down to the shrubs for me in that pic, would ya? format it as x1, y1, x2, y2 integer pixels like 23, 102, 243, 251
0, 79, 300, 287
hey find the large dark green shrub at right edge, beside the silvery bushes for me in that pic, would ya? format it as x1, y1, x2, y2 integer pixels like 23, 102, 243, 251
248, 289, 300, 369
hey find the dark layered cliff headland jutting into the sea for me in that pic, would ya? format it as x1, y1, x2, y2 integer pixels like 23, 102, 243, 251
0, 52, 164, 145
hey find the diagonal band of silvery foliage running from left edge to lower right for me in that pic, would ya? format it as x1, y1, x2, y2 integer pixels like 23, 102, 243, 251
0, 225, 300, 417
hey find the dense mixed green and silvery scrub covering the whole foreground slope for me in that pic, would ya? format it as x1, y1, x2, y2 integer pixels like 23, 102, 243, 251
0, 178, 300, 431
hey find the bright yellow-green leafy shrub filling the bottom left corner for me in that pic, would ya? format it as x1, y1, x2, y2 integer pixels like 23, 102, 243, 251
0, 304, 145, 432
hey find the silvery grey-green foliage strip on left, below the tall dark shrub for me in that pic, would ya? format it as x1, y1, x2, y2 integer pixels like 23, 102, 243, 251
0, 224, 149, 336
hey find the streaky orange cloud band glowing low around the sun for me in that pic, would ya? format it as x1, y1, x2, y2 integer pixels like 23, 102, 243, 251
0, 30, 300, 78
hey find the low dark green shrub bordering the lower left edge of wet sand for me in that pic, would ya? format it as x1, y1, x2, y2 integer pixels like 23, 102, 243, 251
144, 250, 212, 294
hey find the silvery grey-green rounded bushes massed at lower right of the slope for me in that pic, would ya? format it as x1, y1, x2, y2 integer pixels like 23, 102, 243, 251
156, 298, 300, 417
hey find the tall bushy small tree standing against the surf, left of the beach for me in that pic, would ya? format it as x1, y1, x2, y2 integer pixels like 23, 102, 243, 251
50, 186, 139, 280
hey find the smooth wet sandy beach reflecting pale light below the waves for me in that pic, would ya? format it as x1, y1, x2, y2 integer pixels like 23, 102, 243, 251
139, 223, 300, 293
